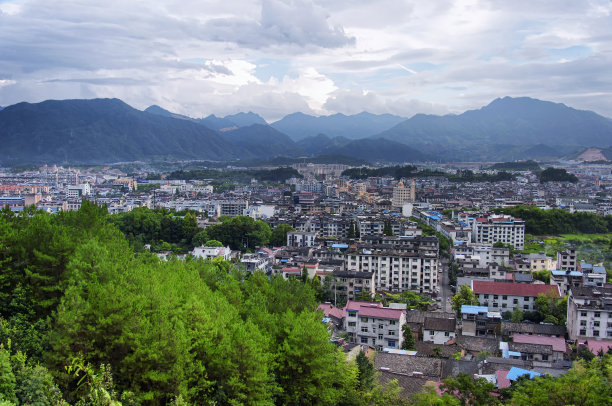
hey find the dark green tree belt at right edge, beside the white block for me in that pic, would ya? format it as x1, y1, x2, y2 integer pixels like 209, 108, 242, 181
494, 206, 612, 235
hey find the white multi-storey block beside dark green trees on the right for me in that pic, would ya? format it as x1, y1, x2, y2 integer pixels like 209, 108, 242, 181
472, 214, 525, 250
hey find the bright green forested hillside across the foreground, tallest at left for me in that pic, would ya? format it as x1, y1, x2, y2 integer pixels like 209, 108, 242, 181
0, 201, 611, 406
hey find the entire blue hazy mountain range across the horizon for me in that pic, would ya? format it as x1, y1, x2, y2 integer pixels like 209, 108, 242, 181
0, 97, 612, 165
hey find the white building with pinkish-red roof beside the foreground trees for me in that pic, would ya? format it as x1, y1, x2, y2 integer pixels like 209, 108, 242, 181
344, 301, 406, 350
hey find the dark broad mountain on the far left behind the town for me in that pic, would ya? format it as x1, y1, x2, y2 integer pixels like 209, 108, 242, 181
0, 99, 239, 163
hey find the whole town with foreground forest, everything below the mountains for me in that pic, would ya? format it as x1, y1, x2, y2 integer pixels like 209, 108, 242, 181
0, 160, 612, 406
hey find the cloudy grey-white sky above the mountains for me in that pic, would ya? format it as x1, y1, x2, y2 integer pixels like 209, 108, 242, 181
0, 0, 612, 121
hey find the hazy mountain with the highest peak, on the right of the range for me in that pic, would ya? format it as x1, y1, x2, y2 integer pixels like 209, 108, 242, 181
375, 97, 612, 152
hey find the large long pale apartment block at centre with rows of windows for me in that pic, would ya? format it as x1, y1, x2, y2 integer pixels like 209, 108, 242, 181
346, 249, 439, 293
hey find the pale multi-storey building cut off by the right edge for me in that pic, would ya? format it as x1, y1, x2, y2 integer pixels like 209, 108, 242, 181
567, 286, 612, 340
